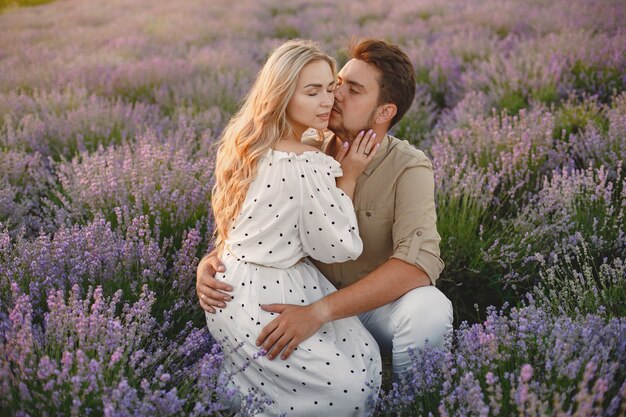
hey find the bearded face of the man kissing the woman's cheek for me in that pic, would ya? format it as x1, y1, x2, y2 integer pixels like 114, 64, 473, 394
328, 59, 380, 142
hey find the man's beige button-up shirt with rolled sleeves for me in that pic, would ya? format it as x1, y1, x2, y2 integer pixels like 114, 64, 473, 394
302, 135, 444, 288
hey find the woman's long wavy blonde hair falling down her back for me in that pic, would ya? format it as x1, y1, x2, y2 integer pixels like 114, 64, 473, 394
211, 40, 336, 253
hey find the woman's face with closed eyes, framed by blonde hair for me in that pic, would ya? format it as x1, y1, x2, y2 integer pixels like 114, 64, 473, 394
287, 60, 335, 139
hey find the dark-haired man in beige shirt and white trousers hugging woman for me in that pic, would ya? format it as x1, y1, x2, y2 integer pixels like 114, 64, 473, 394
196, 39, 452, 375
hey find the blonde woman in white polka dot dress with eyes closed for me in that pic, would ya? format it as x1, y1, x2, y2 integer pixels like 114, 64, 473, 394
207, 41, 381, 416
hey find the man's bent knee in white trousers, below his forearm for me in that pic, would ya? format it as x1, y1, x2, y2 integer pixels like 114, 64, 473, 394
393, 286, 453, 348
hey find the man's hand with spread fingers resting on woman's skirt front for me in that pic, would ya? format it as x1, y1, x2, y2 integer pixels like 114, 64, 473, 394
256, 303, 326, 360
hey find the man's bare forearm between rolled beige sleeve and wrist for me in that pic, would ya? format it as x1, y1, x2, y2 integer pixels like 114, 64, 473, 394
315, 259, 430, 322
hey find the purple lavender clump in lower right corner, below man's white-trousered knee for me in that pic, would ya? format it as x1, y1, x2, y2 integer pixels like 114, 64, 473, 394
370, 300, 626, 416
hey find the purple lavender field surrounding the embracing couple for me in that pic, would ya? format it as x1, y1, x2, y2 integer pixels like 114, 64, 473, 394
0, 0, 626, 417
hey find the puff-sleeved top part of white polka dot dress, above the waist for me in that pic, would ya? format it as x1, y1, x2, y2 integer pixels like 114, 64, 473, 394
227, 151, 362, 268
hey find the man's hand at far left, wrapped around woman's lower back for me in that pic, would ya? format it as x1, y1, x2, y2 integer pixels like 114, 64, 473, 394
196, 252, 233, 314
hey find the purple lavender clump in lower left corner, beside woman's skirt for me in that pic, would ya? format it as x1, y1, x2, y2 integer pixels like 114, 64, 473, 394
0, 285, 266, 416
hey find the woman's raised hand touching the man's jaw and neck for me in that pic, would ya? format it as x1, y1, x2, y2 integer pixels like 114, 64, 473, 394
335, 129, 380, 182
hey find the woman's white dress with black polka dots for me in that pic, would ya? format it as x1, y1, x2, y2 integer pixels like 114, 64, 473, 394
206, 150, 381, 417
